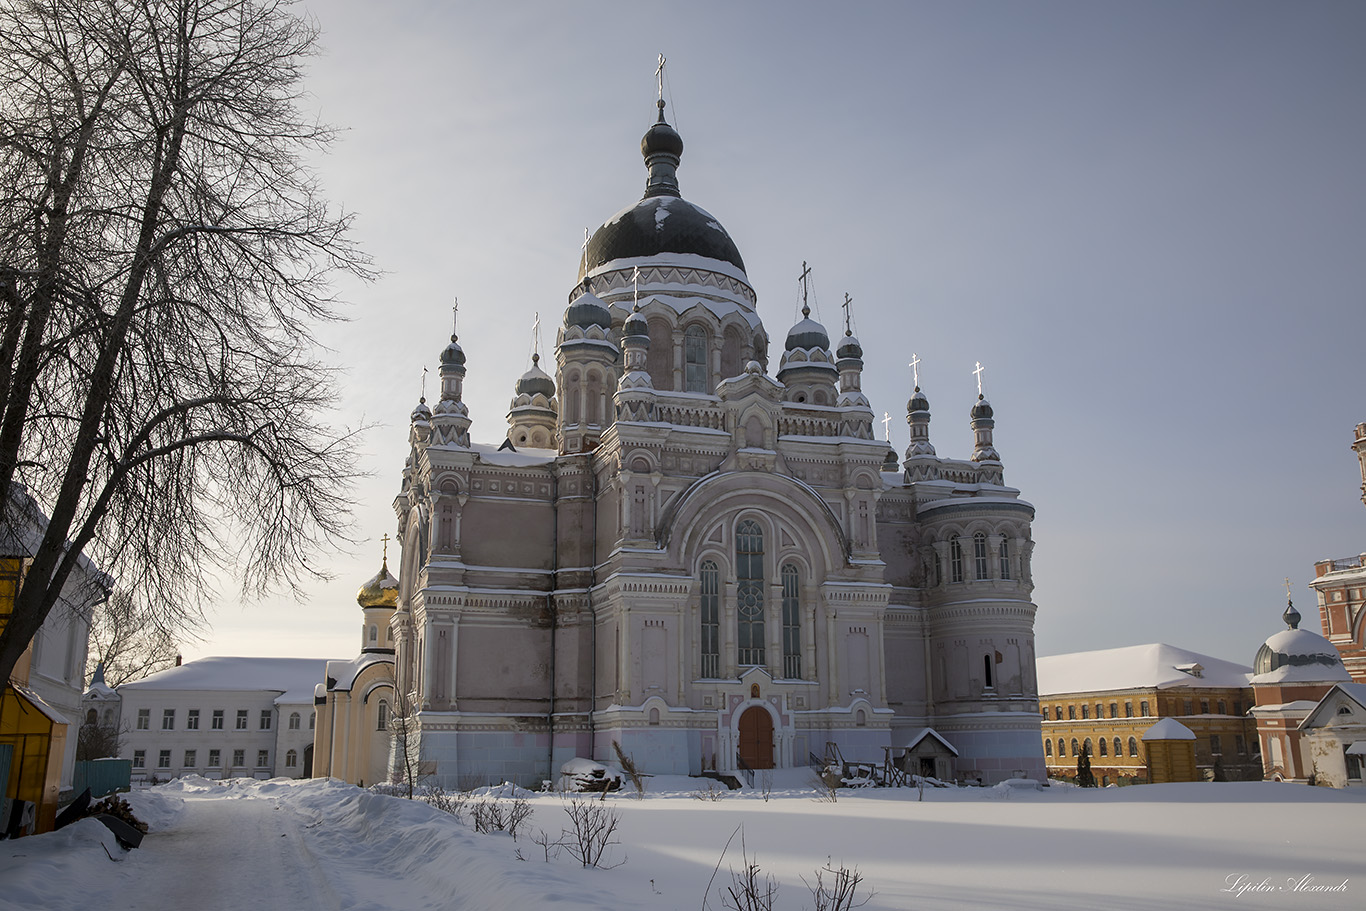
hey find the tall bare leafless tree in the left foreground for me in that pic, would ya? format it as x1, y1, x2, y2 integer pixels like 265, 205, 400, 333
0, 0, 369, 679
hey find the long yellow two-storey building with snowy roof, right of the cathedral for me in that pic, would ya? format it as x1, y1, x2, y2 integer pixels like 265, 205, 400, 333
1038, 643, 1262, 787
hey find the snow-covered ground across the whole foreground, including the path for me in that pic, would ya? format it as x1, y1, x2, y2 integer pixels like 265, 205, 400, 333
0, 772, 1366, 911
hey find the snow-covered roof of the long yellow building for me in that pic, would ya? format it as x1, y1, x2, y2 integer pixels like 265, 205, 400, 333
1037, 642, 1251, 697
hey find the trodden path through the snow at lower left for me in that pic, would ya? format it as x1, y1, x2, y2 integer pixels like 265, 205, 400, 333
126, 796, 342, 911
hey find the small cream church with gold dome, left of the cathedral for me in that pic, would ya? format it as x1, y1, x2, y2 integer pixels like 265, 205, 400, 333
313, 553, 402, 787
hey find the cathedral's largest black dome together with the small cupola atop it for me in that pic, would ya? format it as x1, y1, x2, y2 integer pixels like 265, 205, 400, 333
579, 100, 744, 279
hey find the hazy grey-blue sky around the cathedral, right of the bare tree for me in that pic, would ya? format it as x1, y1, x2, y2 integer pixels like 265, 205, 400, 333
184, 0, 1366, 664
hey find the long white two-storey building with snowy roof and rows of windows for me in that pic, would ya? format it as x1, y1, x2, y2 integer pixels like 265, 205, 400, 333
115, 658, 326, 781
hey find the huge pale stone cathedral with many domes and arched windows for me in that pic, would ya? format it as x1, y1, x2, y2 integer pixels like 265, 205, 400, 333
381, 100, 1044, 787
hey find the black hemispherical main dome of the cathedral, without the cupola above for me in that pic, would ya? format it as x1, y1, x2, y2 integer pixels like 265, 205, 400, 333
579, 195, 744, 279
